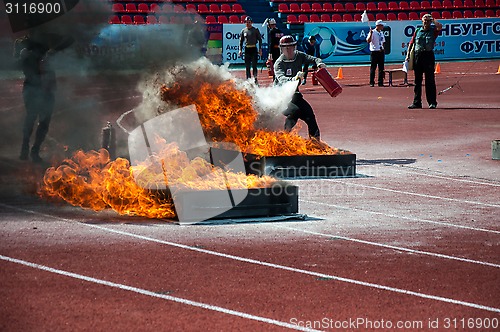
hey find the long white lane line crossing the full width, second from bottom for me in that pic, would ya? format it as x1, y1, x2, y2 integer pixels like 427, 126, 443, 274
0, 203, 500, 313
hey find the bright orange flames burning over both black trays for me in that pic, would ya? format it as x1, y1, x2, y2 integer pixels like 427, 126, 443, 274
40, 61, 346, 218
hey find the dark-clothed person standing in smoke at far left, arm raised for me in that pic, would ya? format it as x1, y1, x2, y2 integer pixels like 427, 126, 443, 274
14, 32, 73, 162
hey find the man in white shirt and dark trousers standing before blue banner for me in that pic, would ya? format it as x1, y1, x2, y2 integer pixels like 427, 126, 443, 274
366, 20, 385, 86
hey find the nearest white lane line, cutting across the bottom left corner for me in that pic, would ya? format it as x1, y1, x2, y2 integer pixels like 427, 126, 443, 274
0, 255, 318, 331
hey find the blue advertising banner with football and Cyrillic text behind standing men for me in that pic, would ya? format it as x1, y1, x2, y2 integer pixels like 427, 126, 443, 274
296, 17, 500, 64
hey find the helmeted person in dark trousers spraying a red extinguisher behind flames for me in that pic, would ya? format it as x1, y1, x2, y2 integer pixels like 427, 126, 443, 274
274, 36, 326, 140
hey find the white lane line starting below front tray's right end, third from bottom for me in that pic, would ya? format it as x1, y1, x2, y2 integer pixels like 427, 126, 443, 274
276, 225, 500, 268
